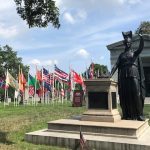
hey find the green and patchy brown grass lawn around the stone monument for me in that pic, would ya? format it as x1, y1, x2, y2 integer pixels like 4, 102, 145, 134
0, 103, 150, 150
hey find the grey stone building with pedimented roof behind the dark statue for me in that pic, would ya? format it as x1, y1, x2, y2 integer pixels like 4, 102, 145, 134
107, 34, 150, 97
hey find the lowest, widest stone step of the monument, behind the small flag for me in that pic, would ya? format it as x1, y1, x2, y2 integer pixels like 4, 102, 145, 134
25, 128, 150, 150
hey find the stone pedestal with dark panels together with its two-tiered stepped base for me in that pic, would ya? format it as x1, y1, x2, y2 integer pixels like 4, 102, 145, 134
25, 79, 150, 150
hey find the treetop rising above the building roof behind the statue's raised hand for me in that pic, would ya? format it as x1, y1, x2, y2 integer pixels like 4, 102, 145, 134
135, 21, 150, 34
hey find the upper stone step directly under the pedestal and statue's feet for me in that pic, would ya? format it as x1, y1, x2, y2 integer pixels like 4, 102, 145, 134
48, 119, 149, 138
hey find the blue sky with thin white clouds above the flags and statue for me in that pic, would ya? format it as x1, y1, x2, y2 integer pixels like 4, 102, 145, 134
0, 0, 150, 73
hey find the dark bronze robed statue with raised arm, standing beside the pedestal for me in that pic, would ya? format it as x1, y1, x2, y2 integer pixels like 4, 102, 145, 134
111, 30, 145, 121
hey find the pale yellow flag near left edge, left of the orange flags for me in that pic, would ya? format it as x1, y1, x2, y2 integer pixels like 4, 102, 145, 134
6, 71, 19, 90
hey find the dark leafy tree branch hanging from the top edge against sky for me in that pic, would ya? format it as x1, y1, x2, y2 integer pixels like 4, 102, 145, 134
14, 0, 60, 28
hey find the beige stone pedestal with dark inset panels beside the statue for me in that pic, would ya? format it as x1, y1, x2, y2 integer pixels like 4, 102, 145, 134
81, 78, 121, 122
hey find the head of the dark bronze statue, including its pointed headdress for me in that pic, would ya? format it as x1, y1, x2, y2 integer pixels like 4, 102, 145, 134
122, 31, 132, 49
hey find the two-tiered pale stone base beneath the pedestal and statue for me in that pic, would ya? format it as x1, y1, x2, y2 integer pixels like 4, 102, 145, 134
25, 119, 150, 150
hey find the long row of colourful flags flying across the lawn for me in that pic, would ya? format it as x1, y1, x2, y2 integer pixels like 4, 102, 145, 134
0, 65, 84, 99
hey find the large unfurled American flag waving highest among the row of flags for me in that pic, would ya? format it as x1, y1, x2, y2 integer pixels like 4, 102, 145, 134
54, 65, 68, 80
